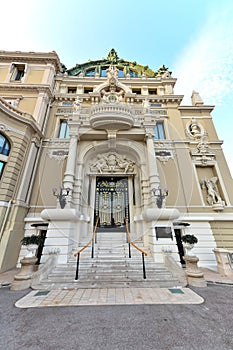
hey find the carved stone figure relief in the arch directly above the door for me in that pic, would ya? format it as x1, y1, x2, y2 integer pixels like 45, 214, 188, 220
89, 152, 135, 174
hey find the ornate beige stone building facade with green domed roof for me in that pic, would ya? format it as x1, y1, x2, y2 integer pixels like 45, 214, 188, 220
0, 49, 233, 271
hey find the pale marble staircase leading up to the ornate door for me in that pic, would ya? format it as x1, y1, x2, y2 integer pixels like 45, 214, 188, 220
33, 232, 180, 290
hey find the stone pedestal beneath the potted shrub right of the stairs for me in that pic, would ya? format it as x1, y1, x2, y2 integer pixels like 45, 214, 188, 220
184, 255, 207, 287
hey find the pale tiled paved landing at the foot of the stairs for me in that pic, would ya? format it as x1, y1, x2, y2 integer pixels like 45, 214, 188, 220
15, 288, 204, 308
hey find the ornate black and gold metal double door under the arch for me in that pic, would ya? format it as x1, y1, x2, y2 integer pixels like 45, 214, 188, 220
95, 177, 129, 227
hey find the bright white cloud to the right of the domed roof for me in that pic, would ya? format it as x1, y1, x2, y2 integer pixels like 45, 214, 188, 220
173, 2, 233, 105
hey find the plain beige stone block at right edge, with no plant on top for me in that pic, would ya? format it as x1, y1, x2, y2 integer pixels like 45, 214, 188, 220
213, 248, 233, 278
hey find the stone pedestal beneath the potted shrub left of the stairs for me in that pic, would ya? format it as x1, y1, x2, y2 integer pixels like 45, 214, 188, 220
11, 256, 37, 290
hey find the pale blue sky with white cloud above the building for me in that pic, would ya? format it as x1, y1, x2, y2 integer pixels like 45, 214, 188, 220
0, 0, 233, 174
